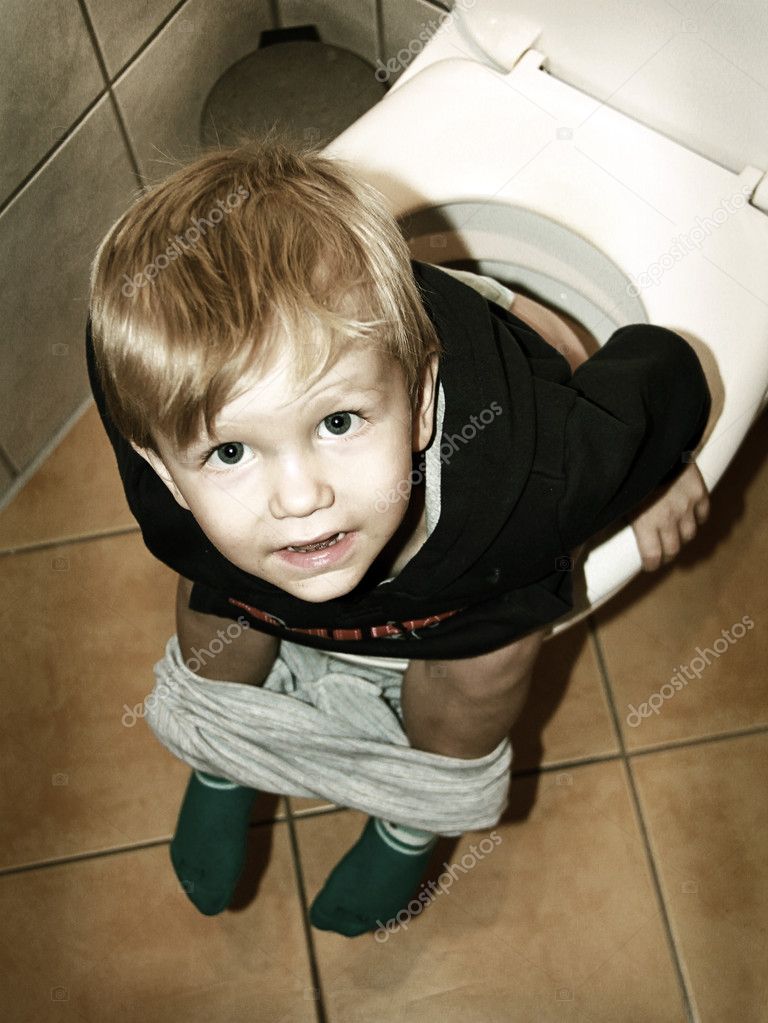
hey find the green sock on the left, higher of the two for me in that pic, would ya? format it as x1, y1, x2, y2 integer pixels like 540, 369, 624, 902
171, 770, 258, 917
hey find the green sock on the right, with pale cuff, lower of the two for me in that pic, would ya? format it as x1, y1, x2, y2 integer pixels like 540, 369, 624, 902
310, 817, 438, 938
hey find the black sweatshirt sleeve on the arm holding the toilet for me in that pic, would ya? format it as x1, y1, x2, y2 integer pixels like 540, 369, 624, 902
557, 323, 712, 549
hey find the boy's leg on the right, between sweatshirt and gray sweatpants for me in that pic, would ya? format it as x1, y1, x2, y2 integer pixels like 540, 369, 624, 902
402, 629, 546, 759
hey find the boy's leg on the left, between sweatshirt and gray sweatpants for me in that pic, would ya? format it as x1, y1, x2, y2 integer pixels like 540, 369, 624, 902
176, 576, 280, 685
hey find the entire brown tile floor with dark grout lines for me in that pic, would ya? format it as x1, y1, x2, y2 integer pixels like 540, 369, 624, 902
0, 406, 768, 1023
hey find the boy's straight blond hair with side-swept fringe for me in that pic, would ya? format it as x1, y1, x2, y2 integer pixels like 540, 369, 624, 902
90, 137, 442, 453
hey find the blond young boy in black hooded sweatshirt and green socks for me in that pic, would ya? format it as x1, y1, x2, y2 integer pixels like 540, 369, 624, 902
87, 142, 710, 936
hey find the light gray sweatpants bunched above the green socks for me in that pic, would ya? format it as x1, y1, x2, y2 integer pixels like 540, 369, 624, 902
144, 635, 512, 836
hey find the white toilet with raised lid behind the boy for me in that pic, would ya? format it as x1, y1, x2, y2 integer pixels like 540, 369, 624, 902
325, 0, 768, 635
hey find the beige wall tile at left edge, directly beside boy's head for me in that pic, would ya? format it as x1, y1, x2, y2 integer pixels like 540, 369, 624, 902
0, 98, 135, 471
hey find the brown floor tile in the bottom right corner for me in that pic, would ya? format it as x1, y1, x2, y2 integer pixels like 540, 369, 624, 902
632, 735, 768, 1023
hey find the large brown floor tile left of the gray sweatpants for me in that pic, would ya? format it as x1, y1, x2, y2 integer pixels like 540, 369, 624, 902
0, 534, 281, 868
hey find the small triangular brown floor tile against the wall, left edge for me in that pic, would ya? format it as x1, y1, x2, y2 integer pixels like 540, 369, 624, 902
0, 405, 138, 550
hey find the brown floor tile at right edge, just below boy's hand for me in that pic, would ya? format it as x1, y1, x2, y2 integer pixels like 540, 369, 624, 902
594, 416, 768, 749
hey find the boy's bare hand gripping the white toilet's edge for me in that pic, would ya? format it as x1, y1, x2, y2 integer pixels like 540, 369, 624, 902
630, 461, 710, 572
